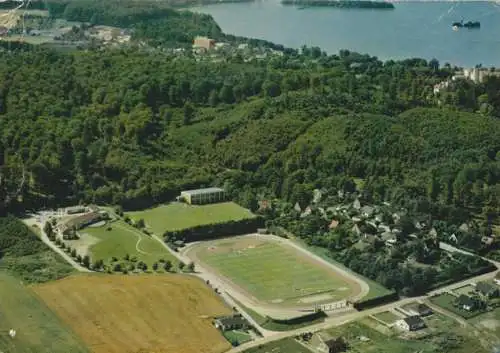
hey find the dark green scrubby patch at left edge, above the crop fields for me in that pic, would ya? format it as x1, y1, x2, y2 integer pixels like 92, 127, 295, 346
0, 217, 73, 283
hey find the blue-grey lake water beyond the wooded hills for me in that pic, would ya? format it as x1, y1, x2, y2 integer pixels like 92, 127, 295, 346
194, 0, 500, 66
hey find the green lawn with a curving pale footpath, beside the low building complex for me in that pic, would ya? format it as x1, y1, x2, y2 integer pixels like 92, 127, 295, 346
85, 220, 177, 268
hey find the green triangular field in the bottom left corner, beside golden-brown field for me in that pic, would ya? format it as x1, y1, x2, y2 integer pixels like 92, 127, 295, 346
0, 272, 89, 353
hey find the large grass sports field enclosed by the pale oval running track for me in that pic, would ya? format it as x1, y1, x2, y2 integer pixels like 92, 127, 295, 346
188, 236, 360, 306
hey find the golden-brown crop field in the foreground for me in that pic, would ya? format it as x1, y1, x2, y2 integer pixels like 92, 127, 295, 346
34, 275, 231, 353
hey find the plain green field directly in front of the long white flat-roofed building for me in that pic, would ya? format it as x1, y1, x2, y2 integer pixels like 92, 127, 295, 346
127, 202, 254, 235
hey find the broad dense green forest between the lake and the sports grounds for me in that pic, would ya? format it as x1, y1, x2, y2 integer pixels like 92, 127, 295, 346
0, 1, 500, 230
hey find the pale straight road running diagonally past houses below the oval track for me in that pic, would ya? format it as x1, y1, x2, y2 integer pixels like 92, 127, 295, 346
227, 270, 498, 353
